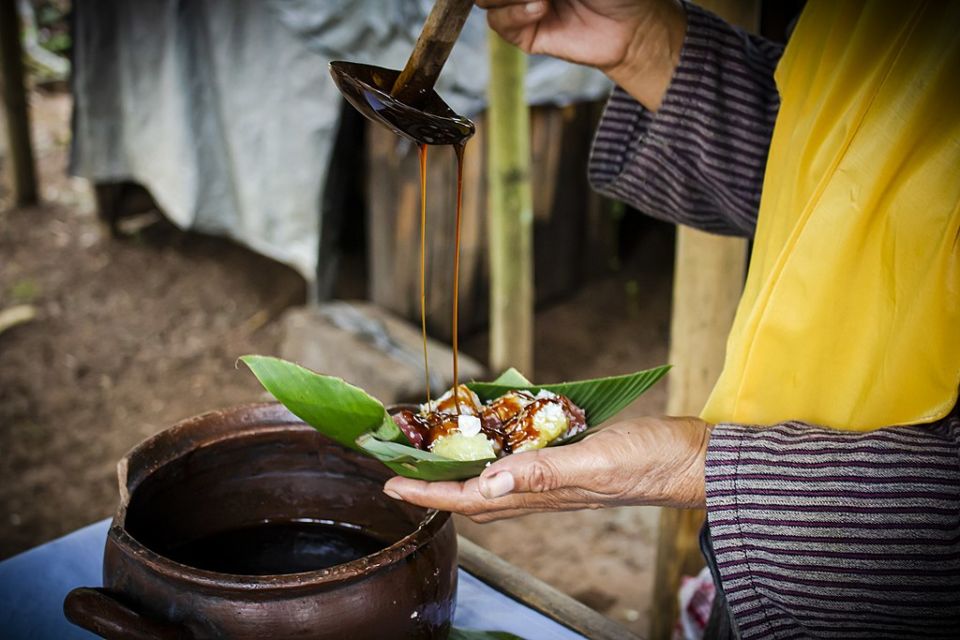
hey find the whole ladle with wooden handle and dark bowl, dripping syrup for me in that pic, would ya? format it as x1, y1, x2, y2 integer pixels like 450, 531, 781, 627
330, 0, 476, 144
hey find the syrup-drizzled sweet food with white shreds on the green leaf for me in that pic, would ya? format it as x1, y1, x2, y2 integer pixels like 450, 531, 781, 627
393, 385, 587, 460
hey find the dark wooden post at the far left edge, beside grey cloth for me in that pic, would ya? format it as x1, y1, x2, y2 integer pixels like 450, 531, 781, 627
0, 0, 37, 206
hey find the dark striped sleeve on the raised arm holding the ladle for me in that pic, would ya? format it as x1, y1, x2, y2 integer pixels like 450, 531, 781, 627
588, 5, 783, 236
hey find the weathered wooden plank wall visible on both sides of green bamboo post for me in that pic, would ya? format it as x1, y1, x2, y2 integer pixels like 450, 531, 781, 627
364, 102, 600, 339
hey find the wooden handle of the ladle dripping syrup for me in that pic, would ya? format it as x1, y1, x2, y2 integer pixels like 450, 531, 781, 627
390, 0, 473, 107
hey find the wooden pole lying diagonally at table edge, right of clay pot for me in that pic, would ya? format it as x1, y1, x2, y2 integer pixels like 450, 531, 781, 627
458, 536, 637, 640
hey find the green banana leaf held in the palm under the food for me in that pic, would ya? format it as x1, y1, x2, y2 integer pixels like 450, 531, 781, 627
240, 356, 669, 481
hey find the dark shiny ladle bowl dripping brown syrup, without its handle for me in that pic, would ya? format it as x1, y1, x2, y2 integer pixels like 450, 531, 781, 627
330, 61, 476, 145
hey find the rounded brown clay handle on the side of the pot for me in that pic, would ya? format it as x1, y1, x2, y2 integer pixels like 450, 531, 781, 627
63, 587, 191, 640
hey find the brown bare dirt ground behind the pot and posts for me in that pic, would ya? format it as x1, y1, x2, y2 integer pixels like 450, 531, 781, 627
0, 94, 672, 632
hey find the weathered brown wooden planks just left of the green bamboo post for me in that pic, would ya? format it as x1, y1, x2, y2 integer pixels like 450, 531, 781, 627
366, 122, 487, 339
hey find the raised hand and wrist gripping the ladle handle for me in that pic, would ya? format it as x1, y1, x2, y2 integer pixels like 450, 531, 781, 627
477, 0, 687, 110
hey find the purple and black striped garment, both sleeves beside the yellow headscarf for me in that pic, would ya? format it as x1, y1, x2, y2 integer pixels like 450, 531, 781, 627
589, 5, 960, 639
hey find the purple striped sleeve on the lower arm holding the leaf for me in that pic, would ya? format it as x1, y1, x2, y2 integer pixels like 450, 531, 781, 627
706, 409, 960, 639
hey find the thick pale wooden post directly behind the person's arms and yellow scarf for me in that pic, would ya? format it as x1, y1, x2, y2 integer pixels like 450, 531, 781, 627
650, 0, 760, 640
